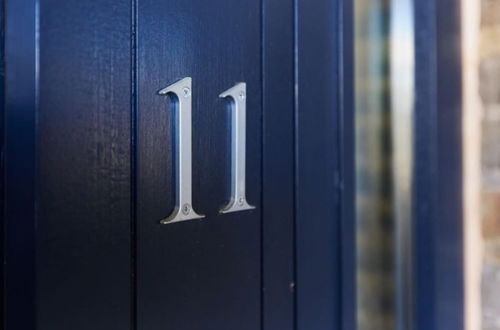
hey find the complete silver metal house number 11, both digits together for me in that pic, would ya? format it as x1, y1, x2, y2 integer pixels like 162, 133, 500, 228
158, 77, 254, 224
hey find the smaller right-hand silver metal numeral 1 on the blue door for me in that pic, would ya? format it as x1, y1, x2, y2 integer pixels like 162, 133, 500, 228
219, 83, 255, 213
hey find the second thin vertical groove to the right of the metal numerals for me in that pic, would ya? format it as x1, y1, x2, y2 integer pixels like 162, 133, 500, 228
293, 0, 300, 330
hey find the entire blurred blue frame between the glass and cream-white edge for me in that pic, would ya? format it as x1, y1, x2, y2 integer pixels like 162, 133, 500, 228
414, 0, 464, 330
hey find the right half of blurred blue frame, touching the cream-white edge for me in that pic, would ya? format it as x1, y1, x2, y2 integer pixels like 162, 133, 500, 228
435, 0, 464, 330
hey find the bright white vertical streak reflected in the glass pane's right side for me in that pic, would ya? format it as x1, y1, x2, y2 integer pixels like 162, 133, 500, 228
390, 0, 415, 330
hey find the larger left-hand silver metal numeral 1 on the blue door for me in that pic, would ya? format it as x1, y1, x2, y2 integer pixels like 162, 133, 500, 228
158, 77, 204, 224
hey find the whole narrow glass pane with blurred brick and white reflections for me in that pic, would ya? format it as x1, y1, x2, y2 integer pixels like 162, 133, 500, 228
355, 0, 413, 330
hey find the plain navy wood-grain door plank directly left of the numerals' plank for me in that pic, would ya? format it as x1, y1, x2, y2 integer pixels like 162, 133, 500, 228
36, 0, 131, 330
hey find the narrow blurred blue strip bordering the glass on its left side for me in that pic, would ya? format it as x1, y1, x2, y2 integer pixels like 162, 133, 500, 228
338, 0, 357, 330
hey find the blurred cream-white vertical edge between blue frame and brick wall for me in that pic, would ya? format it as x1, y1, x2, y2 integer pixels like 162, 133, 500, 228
461, 0, 483, 330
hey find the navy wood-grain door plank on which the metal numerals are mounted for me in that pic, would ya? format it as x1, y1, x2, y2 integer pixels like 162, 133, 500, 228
137, 0, 262, 330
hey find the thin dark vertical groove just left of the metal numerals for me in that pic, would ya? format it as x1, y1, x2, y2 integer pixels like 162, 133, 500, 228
130, 0, 138, 330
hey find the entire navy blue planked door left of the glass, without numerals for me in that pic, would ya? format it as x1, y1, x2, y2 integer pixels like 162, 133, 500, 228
0, 0, 352, 330
